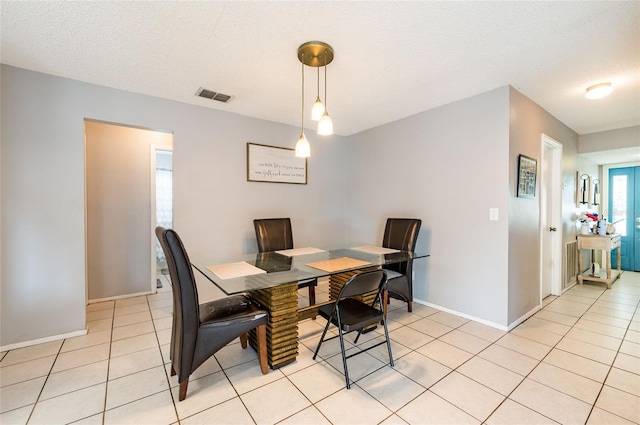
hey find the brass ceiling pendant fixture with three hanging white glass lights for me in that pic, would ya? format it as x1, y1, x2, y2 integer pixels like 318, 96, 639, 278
296, 41, 333, 157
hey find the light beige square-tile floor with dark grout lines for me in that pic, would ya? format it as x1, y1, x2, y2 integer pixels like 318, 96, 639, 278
0, 272, 640, 425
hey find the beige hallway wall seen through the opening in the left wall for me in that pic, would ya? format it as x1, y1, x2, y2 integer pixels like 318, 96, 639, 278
85, 119, 173, 303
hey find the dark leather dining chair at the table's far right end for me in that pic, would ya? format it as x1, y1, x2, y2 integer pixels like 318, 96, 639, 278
382, 218, 422, 312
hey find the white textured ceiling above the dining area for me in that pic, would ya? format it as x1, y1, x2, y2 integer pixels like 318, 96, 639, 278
0, 1, 640, 135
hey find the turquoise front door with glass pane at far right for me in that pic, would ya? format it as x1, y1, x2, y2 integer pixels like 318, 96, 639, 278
607, 167, 640, 271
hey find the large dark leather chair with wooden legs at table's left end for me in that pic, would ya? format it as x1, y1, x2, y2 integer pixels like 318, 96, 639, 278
156, 226, 269, 401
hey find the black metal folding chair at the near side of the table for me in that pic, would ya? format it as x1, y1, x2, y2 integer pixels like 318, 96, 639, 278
313, 269, 393, 389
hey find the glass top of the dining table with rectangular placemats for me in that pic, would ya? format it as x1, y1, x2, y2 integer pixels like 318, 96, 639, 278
191, 246, 429, 295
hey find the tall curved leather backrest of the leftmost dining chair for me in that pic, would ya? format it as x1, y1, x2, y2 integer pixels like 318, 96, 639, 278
156, 226, 200, 379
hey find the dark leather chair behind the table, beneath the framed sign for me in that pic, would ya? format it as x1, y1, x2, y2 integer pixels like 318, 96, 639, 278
253, 217, 318, 305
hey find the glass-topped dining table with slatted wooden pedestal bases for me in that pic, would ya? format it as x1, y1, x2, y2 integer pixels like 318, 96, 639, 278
191, 246, 429, 369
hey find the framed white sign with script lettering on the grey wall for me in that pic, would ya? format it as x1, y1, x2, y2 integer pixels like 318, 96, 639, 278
247, 143, 307, 184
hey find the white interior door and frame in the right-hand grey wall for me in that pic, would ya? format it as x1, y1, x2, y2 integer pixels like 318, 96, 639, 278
539, 133, 563, 296
